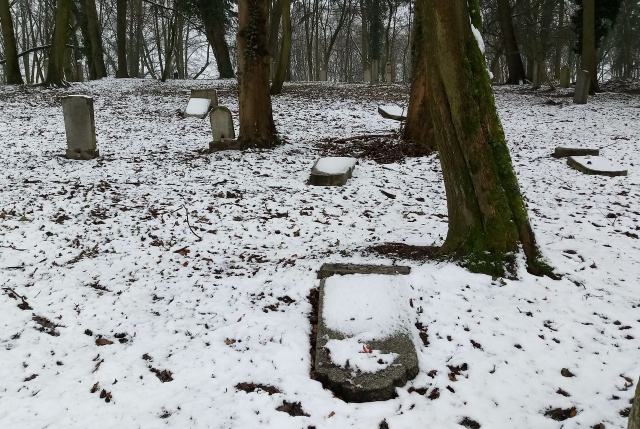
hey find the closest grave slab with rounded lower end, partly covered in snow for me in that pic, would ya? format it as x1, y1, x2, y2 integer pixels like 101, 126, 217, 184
315, 274, 419, 402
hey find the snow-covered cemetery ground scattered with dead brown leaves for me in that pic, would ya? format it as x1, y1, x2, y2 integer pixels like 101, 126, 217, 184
0, 79, 640, 429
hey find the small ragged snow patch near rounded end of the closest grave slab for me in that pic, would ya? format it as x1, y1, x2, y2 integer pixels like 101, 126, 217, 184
325, 337, 398, 374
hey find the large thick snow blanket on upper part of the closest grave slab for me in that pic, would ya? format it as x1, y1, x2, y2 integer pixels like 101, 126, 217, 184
322, 274, 411, 341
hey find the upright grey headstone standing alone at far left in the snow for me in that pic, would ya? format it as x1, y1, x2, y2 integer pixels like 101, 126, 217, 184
62, 95, 99, 159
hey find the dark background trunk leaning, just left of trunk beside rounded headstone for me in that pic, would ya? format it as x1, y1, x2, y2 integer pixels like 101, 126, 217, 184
199, 1, 235, 79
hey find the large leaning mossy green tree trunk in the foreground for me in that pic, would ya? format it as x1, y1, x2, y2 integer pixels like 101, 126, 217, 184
424, 0, 551, 276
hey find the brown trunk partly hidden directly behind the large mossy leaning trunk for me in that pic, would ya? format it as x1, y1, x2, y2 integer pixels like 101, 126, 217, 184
404, 1, 435, 150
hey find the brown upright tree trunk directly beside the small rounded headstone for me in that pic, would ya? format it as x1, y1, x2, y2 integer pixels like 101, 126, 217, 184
237, 0, 277, 148
